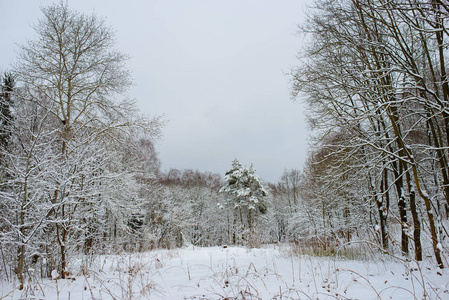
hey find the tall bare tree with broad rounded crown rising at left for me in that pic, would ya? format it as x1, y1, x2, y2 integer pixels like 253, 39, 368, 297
10, 1, 161, 284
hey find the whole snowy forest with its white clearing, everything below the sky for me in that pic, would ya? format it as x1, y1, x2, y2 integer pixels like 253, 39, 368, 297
0, 0, 449, 299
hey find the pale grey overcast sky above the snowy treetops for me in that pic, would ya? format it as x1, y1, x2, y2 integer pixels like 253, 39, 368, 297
0, 0, 308, 182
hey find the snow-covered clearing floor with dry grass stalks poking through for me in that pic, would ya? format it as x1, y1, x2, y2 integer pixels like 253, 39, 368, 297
0, 245, 449, 300
